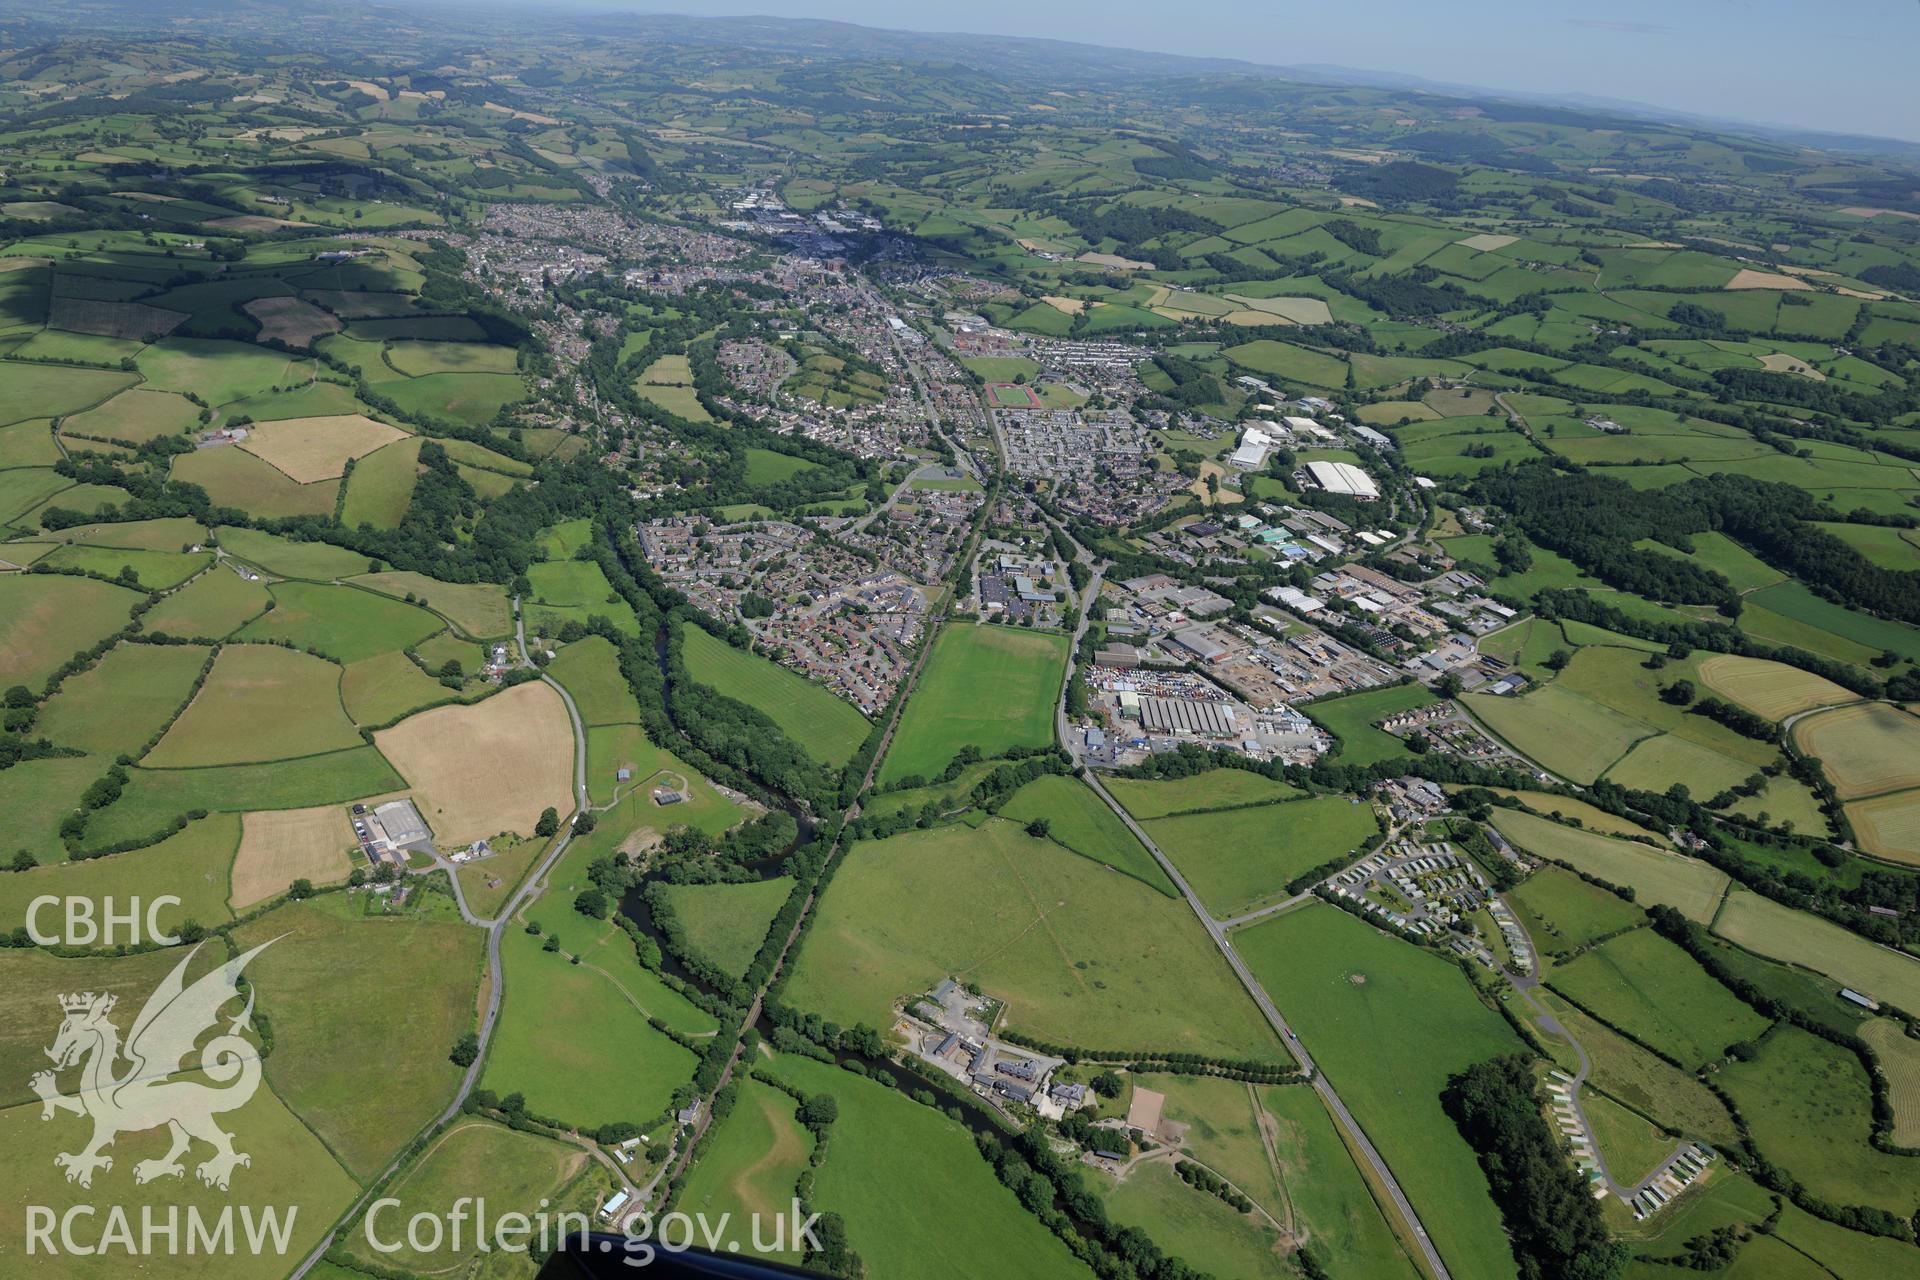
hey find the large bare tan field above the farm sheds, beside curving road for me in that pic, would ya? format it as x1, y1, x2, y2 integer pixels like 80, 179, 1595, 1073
372, 681, 574, 846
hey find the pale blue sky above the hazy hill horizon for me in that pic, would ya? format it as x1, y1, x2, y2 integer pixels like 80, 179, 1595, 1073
579, 0, 1920, 142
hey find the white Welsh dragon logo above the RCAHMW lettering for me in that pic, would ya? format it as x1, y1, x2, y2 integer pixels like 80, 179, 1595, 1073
29, 940, 273, 1192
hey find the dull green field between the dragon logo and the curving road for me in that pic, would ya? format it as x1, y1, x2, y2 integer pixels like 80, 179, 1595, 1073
234, 892, 484, 1178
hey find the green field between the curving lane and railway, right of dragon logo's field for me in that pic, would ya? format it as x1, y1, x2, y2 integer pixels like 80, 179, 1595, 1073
482, 924, 699, 1130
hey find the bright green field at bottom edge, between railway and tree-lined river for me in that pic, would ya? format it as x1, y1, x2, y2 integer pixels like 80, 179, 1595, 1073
766, 1055, 1092, 1280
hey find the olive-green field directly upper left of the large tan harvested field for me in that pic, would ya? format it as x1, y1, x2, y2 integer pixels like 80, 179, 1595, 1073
142, 645, 361, 770
